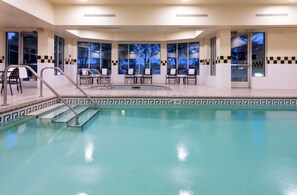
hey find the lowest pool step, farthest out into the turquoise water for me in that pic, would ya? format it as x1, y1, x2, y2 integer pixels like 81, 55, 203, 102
67, 108, 100, 128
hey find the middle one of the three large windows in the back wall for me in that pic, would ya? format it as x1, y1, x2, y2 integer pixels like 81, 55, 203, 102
119, 44, 160, 74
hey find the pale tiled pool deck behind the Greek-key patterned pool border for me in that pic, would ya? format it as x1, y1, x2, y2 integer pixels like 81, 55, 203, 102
0, 84, 297, 113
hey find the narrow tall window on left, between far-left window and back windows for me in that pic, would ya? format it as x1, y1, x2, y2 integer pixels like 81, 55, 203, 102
54, 35, 64, 75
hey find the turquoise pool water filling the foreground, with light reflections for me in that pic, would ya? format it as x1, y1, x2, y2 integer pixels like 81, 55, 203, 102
0, 106, 297, 195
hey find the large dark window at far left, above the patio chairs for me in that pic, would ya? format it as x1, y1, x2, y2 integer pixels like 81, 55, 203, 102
5, 32, 38, 79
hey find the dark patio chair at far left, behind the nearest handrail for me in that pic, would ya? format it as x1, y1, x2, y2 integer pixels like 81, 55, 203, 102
0, 68, 23, 96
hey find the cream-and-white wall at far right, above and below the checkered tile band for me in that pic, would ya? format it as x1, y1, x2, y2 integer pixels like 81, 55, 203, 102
251, 29, 297, 89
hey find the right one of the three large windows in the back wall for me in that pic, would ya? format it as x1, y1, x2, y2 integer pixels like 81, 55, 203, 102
167, 42, 199, 74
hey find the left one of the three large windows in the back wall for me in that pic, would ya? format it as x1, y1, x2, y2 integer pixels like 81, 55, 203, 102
77, 42, 111, 73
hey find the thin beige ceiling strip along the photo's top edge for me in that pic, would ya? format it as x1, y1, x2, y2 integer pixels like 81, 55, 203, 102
46, 0, 297, 5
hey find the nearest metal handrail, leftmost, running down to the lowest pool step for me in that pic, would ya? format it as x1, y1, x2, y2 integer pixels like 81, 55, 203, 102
2, 65, 78, 121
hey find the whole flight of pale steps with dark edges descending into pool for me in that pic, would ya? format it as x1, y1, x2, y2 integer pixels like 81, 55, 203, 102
30, 104, 100, 129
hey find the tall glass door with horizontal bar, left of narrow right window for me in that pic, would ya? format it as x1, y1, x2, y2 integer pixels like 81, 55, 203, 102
231, 34, 250, 87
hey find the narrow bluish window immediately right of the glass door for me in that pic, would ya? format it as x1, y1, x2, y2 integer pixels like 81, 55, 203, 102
252, 32, 265, 76
